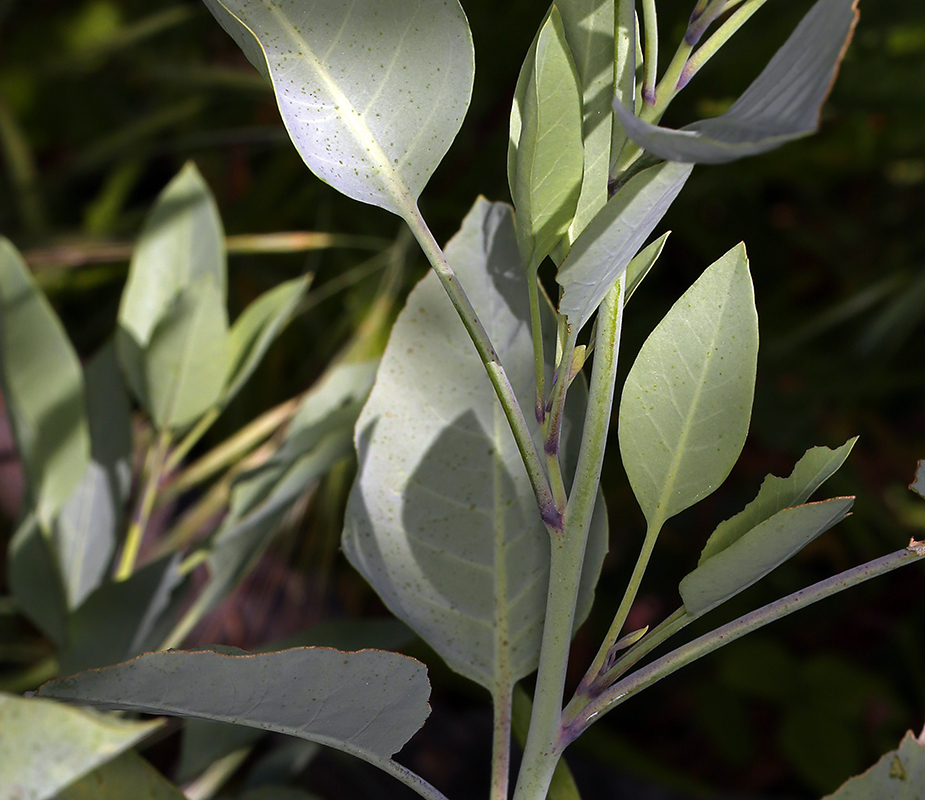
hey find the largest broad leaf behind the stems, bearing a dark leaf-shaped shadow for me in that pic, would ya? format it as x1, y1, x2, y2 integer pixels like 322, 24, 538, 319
343, 199, 607, 692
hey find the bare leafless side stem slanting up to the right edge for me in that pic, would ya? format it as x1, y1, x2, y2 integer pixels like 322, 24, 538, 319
566, 546, 925, 742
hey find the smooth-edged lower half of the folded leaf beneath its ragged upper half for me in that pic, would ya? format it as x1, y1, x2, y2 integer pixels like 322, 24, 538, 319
679, 497, 854, 614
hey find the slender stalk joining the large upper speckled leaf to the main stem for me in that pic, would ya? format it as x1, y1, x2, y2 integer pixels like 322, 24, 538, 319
404, 206, 561, 527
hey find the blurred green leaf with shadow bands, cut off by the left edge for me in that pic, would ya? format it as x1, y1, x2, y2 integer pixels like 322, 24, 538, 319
0, 237, 90, 531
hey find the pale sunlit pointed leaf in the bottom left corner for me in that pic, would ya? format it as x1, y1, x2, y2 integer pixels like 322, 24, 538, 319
0, 694, 161, 800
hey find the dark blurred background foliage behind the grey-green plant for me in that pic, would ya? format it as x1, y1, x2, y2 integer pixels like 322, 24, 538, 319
0, 0, 925, 798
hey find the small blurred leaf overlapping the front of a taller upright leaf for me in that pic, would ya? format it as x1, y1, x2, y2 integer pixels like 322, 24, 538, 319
144, 276, 228, 429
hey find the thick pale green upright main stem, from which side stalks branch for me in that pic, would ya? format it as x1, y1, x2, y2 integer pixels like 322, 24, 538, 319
514, 277, 624, 800
